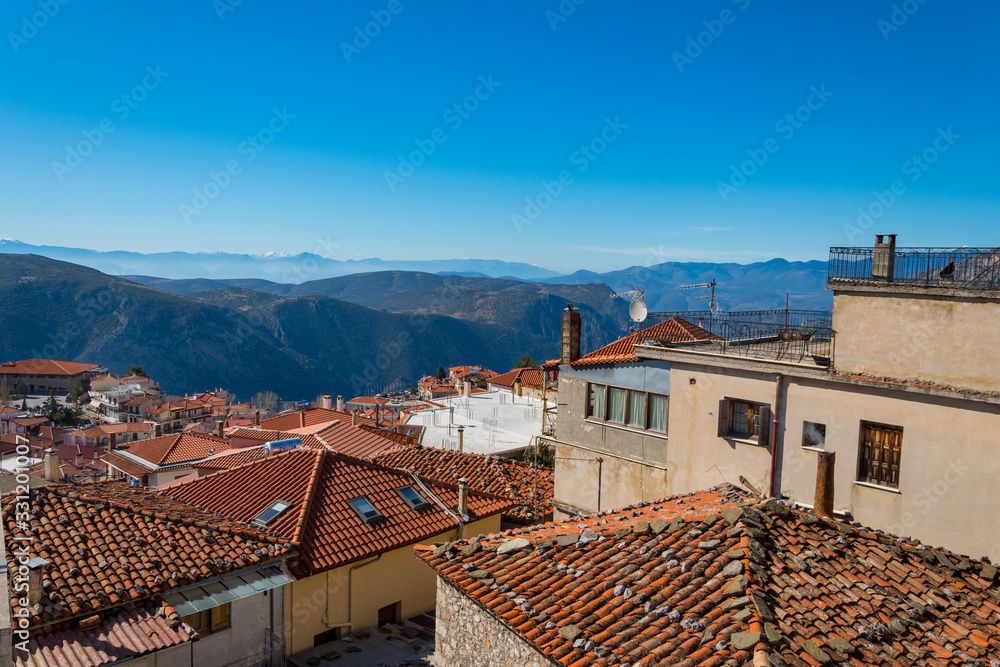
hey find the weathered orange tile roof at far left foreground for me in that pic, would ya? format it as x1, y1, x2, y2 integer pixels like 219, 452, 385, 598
0, 482, 291, 625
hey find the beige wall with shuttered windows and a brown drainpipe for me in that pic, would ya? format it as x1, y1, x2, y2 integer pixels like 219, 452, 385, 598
667, 362, 1000, 560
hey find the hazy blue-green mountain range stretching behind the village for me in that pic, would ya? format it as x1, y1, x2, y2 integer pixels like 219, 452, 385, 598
0, 247, 832, 400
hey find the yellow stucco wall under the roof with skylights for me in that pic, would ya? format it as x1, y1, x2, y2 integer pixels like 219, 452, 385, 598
286, 514, 500, 653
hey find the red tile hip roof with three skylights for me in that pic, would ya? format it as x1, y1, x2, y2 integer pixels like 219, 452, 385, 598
169, 449, 511, 576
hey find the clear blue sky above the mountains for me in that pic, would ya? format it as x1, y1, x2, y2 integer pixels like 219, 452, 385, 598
0, 0, 1000, 271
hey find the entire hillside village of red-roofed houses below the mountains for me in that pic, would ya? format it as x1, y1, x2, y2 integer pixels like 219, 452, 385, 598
0, 234, 1000, 667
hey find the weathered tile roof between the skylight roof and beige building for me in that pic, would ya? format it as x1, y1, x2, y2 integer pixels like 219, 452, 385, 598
371, 446, 555, 524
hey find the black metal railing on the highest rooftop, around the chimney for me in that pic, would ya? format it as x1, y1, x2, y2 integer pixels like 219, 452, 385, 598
827, 246, 1000, 289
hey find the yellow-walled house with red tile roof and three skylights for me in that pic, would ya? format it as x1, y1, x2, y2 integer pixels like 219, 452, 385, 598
166, 448, 512, 653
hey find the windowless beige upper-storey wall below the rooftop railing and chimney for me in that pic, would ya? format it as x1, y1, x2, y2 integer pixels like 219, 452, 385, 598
833, 288, 1000, 391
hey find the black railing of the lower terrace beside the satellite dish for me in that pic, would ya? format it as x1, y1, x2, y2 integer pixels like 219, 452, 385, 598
644, 310, 836, 367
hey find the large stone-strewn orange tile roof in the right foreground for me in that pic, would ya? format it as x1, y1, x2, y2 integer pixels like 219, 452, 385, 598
416, 487, 1000, 667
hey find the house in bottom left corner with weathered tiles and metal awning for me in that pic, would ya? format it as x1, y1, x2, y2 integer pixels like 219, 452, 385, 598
0, 482, 294, 667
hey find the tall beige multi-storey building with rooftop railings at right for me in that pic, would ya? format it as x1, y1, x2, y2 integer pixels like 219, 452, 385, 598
552, 235, 1000, 558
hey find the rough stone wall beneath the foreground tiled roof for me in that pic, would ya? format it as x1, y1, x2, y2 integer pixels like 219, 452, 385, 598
434, 577, 558, 667
